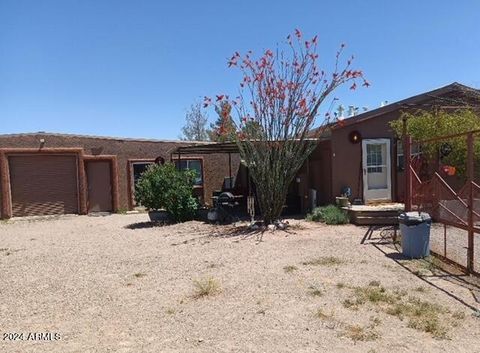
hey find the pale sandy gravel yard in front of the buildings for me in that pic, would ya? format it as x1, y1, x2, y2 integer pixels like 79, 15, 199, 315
0, 214, 480, 353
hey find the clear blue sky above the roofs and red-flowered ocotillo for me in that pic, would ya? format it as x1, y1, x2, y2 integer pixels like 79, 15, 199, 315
0, 0, 480, 139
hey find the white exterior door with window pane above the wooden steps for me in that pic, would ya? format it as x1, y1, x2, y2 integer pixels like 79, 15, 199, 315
362, 139, 392, 202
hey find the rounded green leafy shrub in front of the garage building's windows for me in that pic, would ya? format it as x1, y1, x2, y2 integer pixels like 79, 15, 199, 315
135, 163, 198, 222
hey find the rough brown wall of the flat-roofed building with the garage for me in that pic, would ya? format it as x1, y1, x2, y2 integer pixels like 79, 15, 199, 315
0, 133, 239, 216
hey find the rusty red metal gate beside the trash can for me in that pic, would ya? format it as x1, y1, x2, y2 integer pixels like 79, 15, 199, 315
404, 130, 480, 275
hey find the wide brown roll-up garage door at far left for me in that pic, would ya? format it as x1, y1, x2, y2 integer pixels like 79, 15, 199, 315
8, 155, 78, 217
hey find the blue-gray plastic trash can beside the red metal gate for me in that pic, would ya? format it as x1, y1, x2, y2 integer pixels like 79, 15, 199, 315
398, 212, 432, 259
